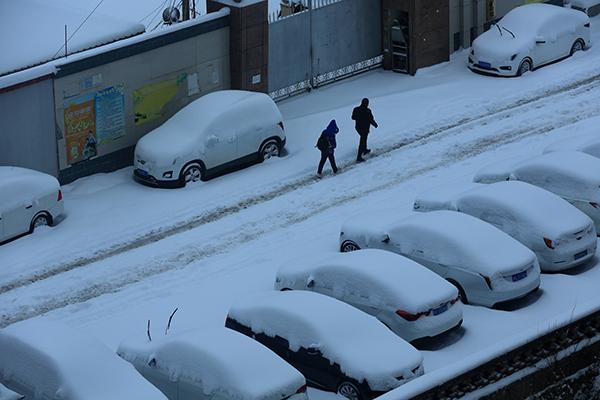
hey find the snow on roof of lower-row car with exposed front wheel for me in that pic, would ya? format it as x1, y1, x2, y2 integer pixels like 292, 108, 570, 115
389, 210, 536, 277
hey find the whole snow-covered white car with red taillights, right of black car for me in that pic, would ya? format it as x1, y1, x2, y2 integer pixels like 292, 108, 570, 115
275, 249, 463, 342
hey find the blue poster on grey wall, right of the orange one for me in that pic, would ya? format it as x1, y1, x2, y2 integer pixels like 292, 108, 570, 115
94, 85, 125, 145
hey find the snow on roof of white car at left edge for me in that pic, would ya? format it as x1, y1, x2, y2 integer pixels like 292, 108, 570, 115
0, 166, 60, 212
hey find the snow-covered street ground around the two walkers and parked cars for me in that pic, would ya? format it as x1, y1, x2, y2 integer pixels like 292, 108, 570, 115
0, 19, 600, 399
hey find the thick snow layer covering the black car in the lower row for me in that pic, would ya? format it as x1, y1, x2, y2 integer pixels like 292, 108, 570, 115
229, 290, 423, 388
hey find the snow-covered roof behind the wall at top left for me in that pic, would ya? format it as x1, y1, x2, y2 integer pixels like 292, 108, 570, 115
0, 0, 145, 76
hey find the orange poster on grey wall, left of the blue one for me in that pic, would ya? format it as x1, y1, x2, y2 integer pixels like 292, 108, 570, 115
64, 95, 96, 164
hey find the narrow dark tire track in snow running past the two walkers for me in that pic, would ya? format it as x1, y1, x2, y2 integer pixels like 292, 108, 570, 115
0, 74, 600, 295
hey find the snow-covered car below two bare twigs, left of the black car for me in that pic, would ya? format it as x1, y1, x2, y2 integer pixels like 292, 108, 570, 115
117, 327, 307, 400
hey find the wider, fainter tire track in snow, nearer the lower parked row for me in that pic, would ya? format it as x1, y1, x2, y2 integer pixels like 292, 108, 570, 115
0, 86, 600, 327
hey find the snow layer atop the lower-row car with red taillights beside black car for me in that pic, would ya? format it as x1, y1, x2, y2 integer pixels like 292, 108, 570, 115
277, 249, 458, 314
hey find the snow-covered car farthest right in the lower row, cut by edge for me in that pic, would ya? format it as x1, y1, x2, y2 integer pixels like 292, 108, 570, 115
473, 151, 600, 234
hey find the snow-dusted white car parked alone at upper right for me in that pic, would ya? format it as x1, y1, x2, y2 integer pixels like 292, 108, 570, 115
469, 4, 591, 76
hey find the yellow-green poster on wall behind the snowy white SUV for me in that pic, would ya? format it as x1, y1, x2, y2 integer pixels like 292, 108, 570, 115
133, 74, 188, 125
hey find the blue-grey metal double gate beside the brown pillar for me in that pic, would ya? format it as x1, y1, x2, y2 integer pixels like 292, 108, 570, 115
269, 0, 382, 99
